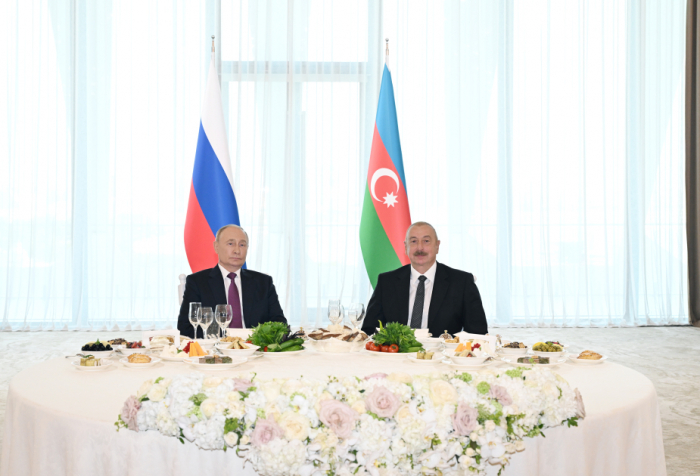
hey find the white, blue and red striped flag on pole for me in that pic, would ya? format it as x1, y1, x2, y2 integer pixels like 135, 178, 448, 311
185, 49, 240, 273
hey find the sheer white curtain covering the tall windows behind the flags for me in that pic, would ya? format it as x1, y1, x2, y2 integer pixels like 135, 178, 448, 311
0, 0, 687, 330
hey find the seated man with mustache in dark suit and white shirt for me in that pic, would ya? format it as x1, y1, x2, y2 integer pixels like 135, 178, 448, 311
362, 222, 488, 337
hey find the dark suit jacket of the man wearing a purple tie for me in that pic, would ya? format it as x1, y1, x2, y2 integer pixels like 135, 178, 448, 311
177, 265, 287, 337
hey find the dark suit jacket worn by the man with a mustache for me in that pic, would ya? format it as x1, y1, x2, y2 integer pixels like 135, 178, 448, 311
362, 263, 488, 337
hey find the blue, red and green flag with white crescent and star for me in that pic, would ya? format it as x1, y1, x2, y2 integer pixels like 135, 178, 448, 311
360, 65, 411, 287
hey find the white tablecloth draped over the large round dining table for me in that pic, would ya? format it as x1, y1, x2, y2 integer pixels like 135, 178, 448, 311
0, 351, 666, 476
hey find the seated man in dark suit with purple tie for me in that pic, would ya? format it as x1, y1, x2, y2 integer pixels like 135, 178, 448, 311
177, 225, 287, 337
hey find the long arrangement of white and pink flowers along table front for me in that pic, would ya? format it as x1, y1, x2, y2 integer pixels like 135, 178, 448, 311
116, 368, 585, 476
